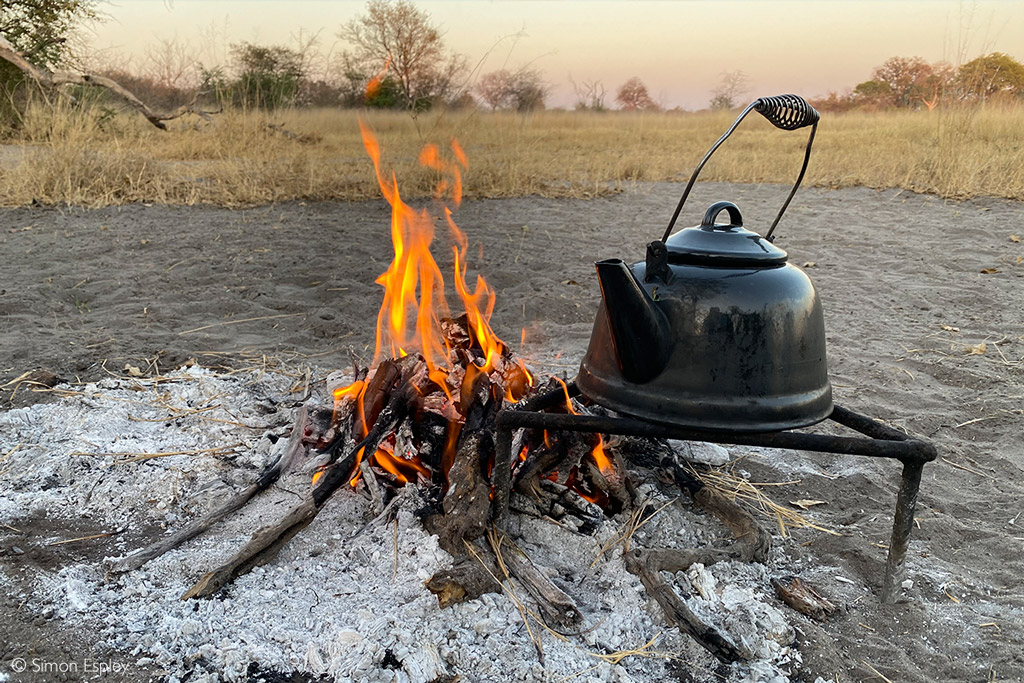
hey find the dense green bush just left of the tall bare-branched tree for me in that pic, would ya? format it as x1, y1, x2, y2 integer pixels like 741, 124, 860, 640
229, 43, 305, 109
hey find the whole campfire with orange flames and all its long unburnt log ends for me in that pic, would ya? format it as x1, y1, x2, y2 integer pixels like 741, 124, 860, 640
109, 117, 782, 661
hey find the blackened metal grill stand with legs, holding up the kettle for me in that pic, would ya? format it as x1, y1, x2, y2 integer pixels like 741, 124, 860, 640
493, 383, 937, 603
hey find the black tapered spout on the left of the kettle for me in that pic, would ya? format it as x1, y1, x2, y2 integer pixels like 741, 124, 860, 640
594, 258, 672, 384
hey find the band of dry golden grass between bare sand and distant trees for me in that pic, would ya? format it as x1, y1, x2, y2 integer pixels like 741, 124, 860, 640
0, 103, 1024, 206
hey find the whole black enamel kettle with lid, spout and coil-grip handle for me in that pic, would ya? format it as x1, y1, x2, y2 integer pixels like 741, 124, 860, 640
577, 95, 833, 432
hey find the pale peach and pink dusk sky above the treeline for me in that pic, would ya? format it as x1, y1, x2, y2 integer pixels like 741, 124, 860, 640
89, 0, 1024, 110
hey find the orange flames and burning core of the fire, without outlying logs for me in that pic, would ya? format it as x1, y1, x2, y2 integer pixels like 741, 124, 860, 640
313, 123, 615, 524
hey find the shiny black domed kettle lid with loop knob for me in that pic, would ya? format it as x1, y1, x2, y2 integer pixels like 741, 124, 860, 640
665, 202, 788, 266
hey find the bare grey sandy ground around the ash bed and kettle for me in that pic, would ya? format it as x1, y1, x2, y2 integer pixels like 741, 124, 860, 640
0, 183, 1024, 682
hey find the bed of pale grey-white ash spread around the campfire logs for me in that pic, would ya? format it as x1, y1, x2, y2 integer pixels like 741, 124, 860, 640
0, 367, 815, 683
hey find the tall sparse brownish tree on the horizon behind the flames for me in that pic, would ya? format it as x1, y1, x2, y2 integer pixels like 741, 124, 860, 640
338, 0, 466, 109
